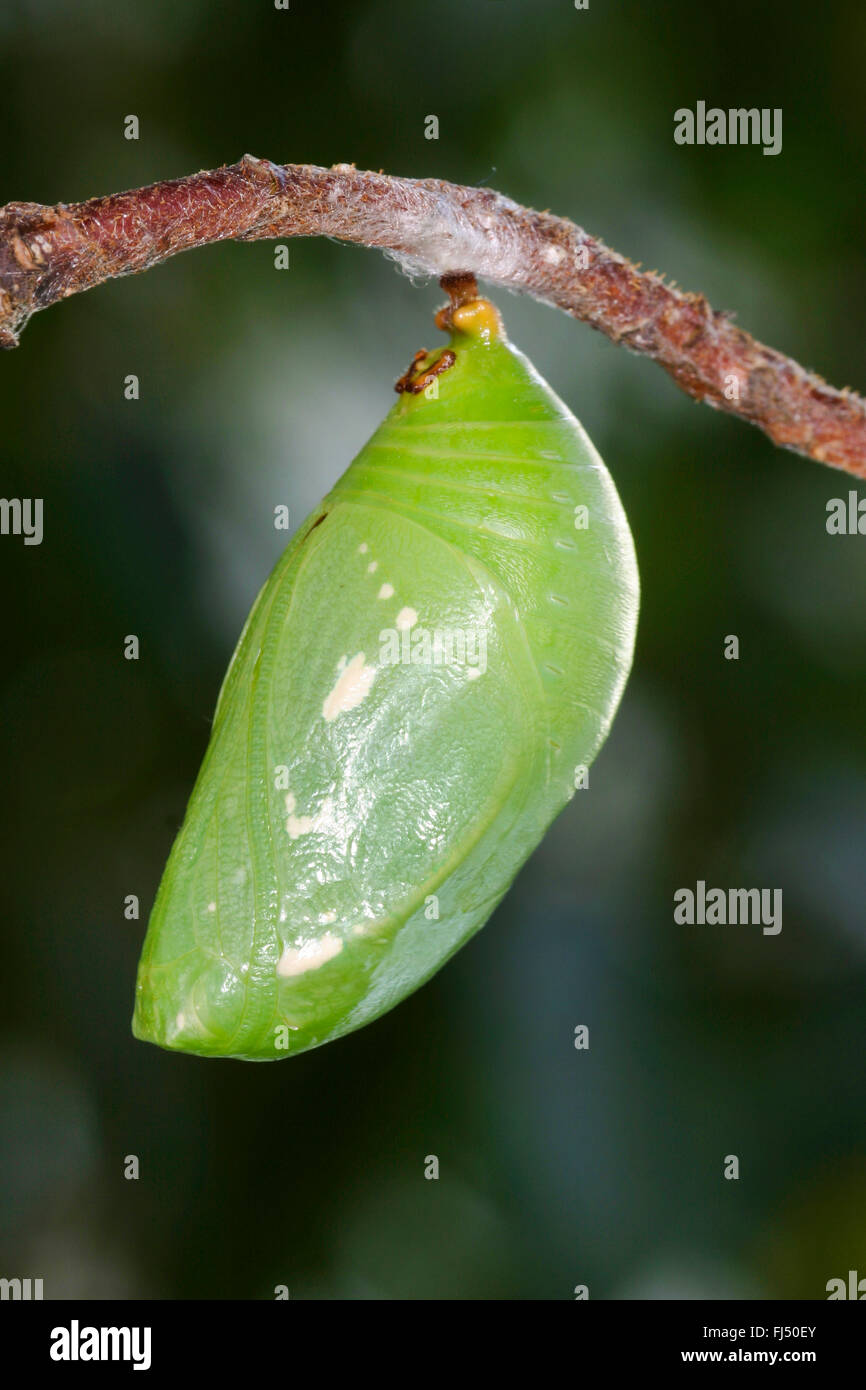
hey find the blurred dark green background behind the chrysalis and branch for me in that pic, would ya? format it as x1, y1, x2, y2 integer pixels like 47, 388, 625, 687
0, 0, 866, 1300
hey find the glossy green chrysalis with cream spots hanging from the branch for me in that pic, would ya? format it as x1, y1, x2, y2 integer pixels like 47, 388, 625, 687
132, 290, 638, 1061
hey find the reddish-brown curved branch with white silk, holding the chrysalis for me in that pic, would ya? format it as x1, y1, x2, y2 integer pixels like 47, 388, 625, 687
0, 154, 866, 477
